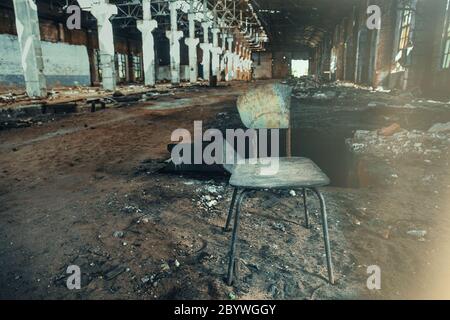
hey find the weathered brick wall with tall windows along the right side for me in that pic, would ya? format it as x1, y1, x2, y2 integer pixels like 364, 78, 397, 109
310, 0, 450, 98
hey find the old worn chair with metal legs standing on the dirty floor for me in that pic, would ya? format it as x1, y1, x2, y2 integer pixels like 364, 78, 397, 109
224, 84, 334, 286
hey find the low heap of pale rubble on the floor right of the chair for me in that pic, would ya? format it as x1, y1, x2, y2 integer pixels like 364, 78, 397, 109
346, 122, 450, 162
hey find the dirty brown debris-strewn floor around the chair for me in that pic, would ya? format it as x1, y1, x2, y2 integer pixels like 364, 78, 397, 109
0, 83, 450, 299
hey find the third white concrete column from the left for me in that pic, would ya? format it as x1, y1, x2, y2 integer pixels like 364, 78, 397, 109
137, 0, 158, 87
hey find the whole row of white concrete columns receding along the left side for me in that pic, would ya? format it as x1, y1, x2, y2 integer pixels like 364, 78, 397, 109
13, 0, 252, 97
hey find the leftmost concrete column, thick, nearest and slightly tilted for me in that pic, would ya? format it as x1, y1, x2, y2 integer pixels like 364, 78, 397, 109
13, 0, 47, 98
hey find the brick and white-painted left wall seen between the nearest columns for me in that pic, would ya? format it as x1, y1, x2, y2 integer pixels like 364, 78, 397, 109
0, 6, 142, 86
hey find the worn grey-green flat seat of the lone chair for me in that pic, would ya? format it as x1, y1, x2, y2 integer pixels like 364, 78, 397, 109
230, 157, 330, 189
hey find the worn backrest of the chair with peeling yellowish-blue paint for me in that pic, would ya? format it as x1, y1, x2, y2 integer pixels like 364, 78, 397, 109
237, 83, 292, 129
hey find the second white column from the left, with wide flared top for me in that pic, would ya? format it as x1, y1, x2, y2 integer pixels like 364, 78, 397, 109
78, 0, 117, 91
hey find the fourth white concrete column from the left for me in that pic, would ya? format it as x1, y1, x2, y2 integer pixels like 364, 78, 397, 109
166, 0, 183, 86
